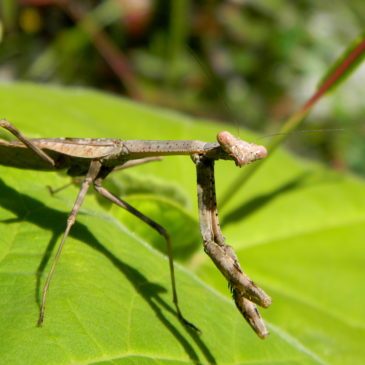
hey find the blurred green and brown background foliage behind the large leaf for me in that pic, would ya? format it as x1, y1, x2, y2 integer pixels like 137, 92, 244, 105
0, 0, 365, 174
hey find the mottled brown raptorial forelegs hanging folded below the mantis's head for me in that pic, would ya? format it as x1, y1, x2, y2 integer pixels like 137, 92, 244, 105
192, 155, 271, 338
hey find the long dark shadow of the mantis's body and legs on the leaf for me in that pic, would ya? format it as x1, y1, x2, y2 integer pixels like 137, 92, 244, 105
0, 180, 216, 364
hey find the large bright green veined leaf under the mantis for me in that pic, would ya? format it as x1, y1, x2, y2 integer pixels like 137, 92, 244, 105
0, 84, 365, 365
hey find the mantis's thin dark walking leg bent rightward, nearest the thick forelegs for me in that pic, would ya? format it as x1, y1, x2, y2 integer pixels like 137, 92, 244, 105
94, 169, 201, 333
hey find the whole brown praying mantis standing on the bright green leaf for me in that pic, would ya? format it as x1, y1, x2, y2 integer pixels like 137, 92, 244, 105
0, 120, 271, 338
